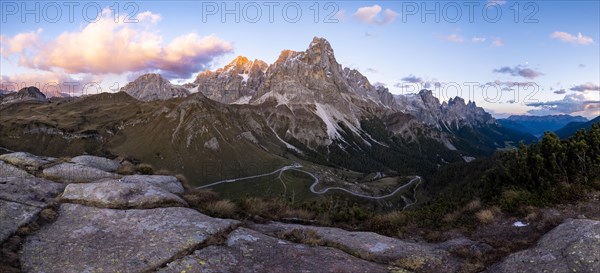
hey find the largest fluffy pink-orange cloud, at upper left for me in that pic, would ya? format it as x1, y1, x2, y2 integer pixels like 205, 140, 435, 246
2, 9, 233, 78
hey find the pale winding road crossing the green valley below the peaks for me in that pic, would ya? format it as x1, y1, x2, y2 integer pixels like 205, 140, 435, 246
196, 163, 422, 200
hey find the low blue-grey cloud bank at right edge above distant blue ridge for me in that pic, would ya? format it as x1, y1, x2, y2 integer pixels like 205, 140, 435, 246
526, 94, 600, 115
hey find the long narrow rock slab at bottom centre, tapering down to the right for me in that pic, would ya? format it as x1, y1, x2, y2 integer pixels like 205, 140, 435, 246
252, 222, 460, 272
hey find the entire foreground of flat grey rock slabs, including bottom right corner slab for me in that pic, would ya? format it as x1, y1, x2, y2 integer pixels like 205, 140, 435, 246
0, 153, 600, 273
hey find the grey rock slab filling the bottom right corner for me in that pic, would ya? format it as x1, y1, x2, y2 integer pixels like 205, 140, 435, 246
487, 220, 600, 273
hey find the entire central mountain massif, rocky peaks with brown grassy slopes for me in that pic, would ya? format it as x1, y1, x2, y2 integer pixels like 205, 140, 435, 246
0, 38, 536, 183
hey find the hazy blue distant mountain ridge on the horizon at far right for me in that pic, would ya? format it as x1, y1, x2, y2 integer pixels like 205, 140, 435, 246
498, 115, 588, 137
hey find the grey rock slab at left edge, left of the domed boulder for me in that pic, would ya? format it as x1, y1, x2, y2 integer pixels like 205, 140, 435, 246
0, 176, 65, 208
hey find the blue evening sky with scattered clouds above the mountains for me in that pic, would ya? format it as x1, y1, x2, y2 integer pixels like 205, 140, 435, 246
0, 0, 600, 118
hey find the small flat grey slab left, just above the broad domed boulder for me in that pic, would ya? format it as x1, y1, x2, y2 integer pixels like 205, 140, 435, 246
43, 163, 119, 183
